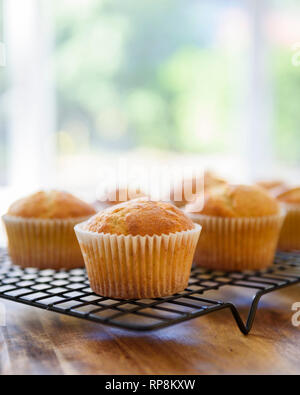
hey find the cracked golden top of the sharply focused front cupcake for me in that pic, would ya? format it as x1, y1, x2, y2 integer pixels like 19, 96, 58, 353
84, 198, 194, 236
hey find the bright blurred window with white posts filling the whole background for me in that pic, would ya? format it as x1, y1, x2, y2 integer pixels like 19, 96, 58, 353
0, 0, 300, 207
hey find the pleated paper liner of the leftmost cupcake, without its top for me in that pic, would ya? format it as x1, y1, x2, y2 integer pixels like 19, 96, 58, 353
2, 215, 92, 269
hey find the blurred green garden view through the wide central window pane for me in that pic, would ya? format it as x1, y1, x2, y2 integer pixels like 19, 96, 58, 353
55, 0, 240, 158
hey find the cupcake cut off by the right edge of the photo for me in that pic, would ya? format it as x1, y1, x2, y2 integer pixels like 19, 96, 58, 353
277, 187, 300, 251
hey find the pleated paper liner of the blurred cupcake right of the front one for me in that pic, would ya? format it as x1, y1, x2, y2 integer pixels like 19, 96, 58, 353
187, 213, 284, 271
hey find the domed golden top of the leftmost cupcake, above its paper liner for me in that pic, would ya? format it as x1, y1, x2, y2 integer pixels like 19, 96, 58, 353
7, 191, 96, 219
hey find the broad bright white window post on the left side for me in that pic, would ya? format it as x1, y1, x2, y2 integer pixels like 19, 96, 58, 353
4, 0, 55, 198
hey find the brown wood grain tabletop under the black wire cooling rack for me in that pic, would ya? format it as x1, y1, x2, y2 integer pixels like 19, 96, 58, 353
0, 286, 300, 375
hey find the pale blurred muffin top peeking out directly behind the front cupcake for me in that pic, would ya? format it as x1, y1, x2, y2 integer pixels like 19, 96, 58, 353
94, 187, 147, 211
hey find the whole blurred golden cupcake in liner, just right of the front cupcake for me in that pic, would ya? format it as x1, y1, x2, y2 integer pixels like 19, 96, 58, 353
186, 185, 284, 271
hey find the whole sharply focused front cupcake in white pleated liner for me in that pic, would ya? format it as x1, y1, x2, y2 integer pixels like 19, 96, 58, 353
75, 198, 201, 299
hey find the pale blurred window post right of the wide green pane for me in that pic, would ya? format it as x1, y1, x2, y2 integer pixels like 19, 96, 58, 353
242, 0, 274, 180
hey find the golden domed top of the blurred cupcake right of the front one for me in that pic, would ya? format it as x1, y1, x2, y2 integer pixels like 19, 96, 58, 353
186, 185, 280, 217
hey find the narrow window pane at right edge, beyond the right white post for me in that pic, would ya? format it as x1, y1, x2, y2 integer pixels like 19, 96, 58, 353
268, 1, 300, 180
